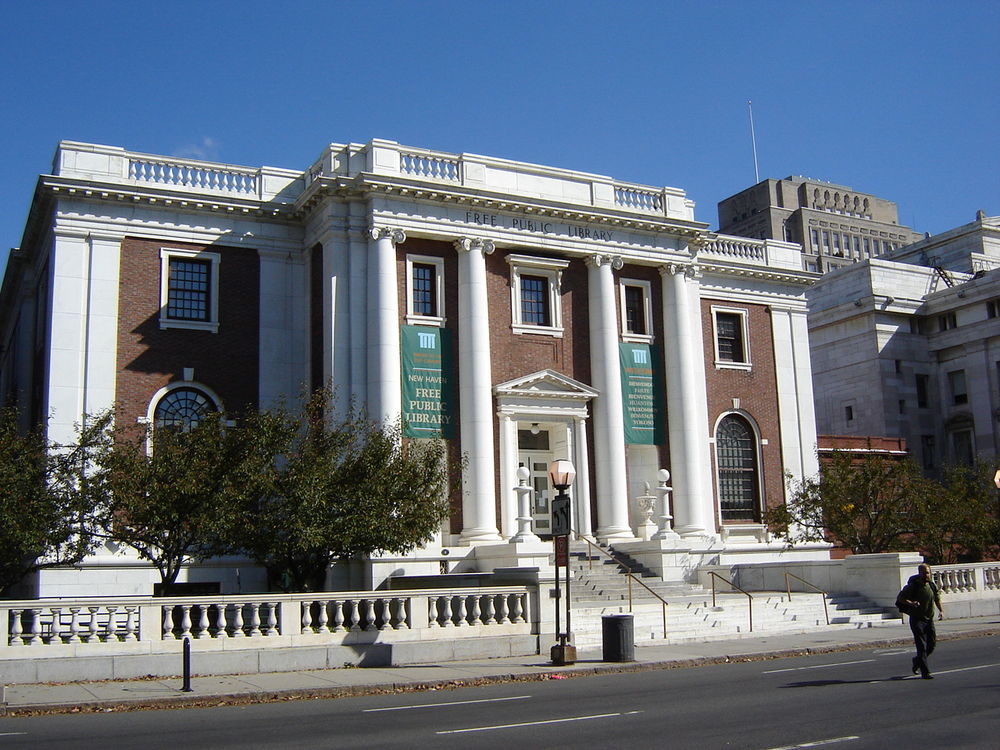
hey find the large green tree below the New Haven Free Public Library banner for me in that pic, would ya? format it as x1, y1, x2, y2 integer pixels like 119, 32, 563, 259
231, 389, 449, 591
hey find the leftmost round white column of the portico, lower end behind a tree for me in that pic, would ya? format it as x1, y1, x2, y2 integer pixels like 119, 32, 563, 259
368, 227, 406, 424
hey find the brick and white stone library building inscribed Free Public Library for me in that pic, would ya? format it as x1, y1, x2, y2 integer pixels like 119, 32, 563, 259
0, 140, 828, 595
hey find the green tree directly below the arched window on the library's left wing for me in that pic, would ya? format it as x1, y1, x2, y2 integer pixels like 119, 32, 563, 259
92, 413, 280, 588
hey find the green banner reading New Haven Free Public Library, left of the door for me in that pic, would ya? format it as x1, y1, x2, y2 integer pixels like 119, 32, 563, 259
402, 326, 455, 438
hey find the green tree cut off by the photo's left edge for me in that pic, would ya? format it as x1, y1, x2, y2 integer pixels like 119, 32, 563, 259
0, 408, 99, 593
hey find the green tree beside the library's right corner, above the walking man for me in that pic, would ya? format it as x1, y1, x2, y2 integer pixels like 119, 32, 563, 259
764, 452, 939, 553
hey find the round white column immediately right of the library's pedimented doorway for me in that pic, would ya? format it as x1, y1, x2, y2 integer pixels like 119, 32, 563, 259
587, 255, 634, 539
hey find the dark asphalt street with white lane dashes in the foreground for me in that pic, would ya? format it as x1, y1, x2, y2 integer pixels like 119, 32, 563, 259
0, 637, 1000, 750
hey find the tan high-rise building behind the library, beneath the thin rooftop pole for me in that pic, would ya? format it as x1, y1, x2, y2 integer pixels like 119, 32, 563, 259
718, 177, 923, 273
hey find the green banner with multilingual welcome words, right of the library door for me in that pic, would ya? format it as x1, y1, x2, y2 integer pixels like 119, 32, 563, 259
618, 344, 666, 445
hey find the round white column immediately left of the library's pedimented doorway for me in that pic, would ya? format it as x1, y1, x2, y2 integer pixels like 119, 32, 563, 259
455, 237, 500, 544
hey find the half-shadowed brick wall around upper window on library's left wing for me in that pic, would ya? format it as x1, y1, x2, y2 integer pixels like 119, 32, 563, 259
116, 237, 260, 422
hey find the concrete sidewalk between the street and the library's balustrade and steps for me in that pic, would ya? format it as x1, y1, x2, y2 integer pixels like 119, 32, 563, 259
0, 617, 1000, 716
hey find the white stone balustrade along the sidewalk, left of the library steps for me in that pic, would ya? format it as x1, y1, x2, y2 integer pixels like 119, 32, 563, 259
0, 586, 538, 658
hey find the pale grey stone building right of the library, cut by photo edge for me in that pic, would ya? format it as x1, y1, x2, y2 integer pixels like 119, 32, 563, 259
808, 212, 1000, 473
